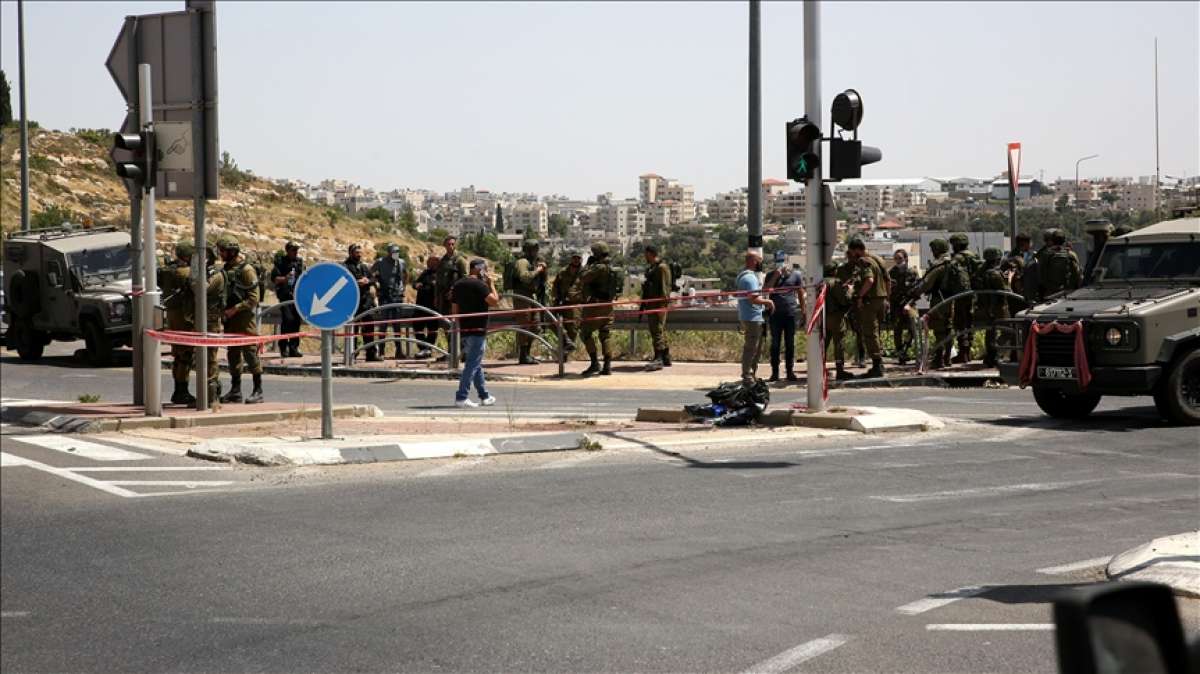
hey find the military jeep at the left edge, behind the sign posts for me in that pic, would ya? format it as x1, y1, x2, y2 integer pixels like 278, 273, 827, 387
4, 227, 133, 366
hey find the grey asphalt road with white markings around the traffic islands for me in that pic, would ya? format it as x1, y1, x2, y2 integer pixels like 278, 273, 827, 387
0, 342, 1200, 673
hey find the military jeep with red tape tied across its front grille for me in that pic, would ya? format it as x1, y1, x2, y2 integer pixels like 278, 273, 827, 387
1001, 217, 1200, 426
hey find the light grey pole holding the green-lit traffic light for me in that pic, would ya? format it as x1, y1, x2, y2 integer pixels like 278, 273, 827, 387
804, 0, 829, 411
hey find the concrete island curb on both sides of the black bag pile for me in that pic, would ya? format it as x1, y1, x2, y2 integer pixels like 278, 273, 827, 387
636, 408, 946, 433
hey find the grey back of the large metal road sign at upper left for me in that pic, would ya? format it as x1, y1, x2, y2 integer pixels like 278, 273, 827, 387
106, 9, 220, 199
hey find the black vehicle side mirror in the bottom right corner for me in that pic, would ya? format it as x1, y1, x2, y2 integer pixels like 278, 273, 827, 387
1054, 582, 1189, 674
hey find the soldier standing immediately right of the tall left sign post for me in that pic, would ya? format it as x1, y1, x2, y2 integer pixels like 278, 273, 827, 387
217, 234, 263, 404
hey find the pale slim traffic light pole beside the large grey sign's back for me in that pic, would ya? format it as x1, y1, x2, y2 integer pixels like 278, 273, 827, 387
138, 64, 162, 416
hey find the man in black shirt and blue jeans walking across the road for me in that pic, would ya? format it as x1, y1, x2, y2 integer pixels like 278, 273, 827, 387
450, 259, 500, 408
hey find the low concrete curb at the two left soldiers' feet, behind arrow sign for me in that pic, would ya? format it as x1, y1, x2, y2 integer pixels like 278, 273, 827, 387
0, 405, 383, 433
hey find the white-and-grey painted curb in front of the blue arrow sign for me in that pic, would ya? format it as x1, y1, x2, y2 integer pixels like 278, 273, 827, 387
187, 433, 600, 465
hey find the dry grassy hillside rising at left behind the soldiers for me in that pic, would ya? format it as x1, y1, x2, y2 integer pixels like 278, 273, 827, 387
0, 126, 440, 261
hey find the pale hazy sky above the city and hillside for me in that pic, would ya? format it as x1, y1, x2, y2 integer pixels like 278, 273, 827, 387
0, 0, 1200, 198
